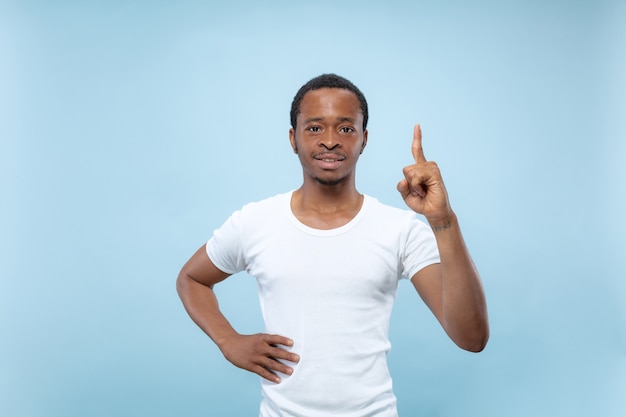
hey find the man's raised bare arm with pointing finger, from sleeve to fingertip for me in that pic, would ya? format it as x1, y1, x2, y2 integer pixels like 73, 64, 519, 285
398, 125, 489, 352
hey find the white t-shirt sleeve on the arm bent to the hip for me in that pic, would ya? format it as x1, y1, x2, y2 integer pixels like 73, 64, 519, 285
206, 211, 245, 275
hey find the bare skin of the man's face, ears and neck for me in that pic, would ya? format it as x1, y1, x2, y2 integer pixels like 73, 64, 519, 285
289, 88, 367, 229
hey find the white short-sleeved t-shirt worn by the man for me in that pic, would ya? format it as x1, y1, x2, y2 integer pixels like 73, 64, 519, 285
206, 192, 439, 417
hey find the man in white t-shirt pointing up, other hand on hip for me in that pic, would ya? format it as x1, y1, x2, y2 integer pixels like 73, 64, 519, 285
177, 74, 489, 417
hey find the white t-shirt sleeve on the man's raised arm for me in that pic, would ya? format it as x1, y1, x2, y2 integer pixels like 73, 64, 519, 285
402, 216, 441, 279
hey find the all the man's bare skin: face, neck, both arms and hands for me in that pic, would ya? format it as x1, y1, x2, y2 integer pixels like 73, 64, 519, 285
176, 88, 489, 383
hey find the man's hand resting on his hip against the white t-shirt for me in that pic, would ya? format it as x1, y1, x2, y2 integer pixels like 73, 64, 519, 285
220, 333, 300, 383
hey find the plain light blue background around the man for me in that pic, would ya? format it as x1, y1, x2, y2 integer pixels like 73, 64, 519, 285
0, 0, 626, 417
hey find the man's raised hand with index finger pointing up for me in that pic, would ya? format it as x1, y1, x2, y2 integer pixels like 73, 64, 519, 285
397, 124, 453, 228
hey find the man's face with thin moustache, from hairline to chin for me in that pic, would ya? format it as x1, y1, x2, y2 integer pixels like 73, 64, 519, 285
289, 88, 367, 185
